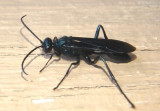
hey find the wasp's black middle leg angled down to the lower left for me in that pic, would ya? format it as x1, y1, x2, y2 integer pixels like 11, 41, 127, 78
54, 57, 80, 90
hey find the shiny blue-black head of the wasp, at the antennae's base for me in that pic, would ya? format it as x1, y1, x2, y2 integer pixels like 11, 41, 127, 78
43, 38, 52, 53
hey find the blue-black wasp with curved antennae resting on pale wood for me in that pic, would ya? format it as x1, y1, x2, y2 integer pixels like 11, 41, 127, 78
21, 15, 136, 108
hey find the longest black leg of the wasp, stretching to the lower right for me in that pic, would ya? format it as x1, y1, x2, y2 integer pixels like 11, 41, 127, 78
85, 56, 135, 108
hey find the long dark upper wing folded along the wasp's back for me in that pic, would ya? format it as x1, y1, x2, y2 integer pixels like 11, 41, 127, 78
69, 37, 136, 53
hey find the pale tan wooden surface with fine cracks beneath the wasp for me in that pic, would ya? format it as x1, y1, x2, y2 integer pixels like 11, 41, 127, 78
0, 0, 160, 111
